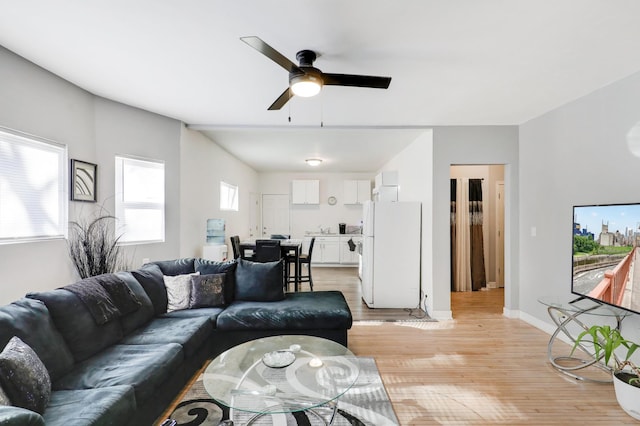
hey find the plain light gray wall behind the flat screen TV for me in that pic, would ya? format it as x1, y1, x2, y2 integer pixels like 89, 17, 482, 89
520, 73, 640, 334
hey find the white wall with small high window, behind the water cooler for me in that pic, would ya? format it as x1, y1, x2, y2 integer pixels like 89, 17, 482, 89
179, 126, 258, 257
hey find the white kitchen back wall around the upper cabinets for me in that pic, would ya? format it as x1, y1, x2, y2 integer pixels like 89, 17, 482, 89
260, 172, 375, 238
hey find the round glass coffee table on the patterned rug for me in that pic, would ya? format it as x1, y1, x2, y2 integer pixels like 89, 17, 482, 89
203, 335, 360, 425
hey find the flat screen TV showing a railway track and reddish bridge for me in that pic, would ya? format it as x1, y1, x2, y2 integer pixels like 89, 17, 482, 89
571, 203, 640, 313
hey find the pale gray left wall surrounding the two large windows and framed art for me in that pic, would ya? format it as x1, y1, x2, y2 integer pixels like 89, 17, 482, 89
0, 47, 180, 304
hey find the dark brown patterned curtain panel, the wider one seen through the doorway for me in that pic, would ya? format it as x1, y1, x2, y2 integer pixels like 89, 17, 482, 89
469, 179, 487, 290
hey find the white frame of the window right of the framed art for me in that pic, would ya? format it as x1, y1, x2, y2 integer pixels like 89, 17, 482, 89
114, 154, 166, 246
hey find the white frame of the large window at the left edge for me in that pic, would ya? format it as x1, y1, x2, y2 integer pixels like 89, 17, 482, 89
0, 126, 69, 245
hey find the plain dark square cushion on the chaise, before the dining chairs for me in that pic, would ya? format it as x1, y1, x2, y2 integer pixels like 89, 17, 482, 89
233, 259, 284, 302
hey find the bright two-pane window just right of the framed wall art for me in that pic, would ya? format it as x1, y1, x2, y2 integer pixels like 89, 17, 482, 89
116, 156, 164, 244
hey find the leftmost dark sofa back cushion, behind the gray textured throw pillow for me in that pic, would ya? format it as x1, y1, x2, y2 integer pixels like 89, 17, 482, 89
0, 298, 74, 380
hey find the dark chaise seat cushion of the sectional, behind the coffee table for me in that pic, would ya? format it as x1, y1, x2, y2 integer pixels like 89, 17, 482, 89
217, 291, 353, 331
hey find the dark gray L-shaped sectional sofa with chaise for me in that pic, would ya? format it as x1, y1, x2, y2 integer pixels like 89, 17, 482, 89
0, 258, 352, 426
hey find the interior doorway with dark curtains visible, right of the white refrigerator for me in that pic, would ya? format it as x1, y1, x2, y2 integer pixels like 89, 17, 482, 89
450, 165, 505, 314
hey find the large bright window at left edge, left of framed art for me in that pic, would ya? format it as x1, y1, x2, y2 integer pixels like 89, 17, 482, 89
0, 129, 68, 243
